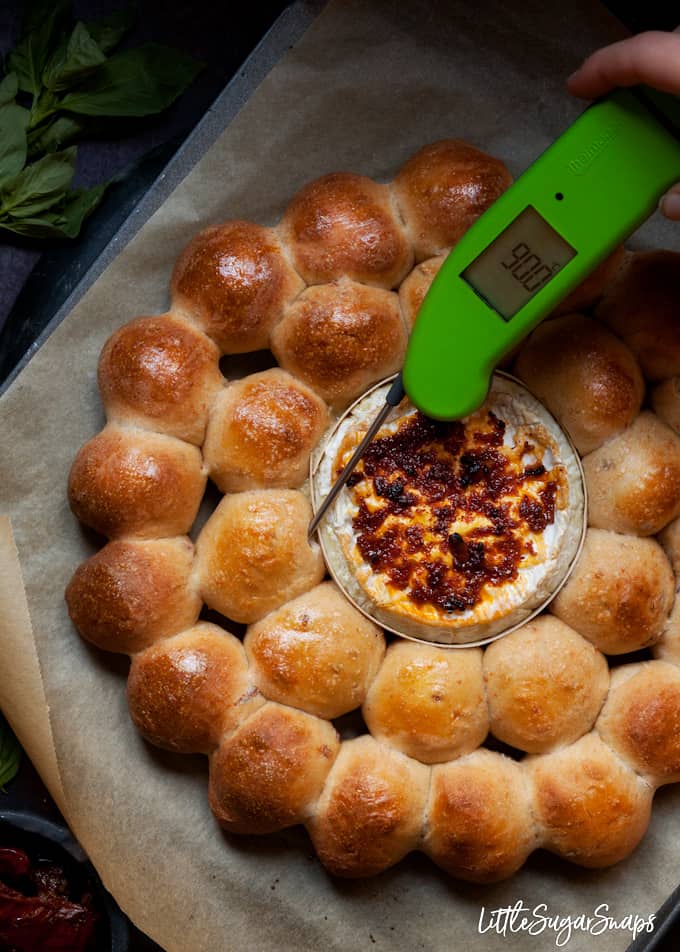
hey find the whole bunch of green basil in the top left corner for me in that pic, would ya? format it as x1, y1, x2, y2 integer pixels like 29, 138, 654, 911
0, 0, 201, 238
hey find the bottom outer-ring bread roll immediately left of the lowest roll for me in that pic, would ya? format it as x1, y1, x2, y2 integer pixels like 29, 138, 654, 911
307, 734, 430, 877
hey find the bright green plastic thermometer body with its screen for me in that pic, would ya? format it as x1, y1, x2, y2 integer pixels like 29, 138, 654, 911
402, 87, 680, 420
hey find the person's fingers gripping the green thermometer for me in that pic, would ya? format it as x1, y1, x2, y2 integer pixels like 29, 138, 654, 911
567, 28, 680, 221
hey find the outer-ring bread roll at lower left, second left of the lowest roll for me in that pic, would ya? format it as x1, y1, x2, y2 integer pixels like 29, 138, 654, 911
208, 701, 340, 833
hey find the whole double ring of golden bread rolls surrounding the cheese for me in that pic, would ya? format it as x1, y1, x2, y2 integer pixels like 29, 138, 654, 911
66, 140, 680, 883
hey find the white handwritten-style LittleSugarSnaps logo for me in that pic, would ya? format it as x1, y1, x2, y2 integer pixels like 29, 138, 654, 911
477, 899, 656, 949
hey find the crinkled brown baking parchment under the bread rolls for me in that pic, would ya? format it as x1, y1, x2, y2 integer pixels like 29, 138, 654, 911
0, 0, 680, 952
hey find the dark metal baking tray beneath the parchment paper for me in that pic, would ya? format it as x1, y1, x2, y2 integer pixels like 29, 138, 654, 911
0, 0, 680, 952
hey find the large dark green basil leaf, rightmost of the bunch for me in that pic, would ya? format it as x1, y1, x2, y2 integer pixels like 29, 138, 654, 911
60, 43, 203, 116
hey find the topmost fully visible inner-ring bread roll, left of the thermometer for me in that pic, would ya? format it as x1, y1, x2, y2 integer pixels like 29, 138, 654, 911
271, 279, 407, 410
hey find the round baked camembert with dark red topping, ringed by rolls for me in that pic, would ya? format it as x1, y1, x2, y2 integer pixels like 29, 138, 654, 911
312, 374, 585, 644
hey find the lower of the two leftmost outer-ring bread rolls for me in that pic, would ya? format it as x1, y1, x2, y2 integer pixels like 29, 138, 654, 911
66, 537, 201, 654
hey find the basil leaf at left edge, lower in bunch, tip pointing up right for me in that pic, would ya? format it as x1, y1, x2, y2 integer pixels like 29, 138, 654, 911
0, 146, 76, 218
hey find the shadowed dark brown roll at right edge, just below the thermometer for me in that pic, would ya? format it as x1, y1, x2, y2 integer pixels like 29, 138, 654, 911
596, 251, 680, 380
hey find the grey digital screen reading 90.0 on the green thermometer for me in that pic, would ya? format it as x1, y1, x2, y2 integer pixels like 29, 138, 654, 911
461, 205, 576, 321
